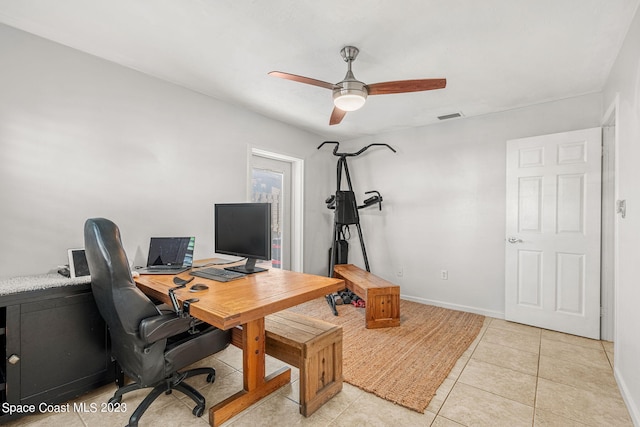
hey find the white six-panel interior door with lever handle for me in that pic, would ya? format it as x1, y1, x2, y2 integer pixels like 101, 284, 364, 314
505, 128, 602, 339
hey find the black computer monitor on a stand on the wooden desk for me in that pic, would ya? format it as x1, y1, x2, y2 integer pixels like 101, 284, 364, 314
213, 203, 271, 274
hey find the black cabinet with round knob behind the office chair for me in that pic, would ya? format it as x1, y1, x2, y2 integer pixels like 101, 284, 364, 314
0, 284, 115, 423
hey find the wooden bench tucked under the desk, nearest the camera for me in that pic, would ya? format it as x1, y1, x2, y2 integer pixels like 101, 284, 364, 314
231, 311, 342, 417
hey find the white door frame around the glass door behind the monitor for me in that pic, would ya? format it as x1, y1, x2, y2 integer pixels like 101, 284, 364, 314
247, 146, 304, 272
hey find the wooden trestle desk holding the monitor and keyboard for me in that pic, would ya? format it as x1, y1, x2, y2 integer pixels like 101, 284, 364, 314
135, 266, 345, 426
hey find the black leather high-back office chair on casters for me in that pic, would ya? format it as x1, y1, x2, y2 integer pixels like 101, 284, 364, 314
84, 218, 231, 427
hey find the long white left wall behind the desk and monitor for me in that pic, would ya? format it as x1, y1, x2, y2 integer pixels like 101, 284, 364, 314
0, 25, 330, 278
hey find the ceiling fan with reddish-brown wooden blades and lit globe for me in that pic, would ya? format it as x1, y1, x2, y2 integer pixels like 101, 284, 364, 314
269, 46, 447, 125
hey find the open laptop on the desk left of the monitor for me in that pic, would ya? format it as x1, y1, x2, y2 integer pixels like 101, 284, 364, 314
136, 237, 196, 274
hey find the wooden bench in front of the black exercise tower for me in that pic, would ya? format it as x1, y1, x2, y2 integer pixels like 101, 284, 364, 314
333, 264, 400, 329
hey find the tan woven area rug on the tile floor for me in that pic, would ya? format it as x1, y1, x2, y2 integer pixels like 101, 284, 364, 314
291, 298, 484, 413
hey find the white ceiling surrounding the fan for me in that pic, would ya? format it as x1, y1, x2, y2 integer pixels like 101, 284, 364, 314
0, 0, 640, 138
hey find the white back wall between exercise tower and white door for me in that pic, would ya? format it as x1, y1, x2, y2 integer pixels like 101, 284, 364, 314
341, 94, 602, 317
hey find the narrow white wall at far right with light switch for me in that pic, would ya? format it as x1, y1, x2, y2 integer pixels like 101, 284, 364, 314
604, 4, 640, 426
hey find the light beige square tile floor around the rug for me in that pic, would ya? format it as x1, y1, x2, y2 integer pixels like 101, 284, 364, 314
9, 318, 633, 427
